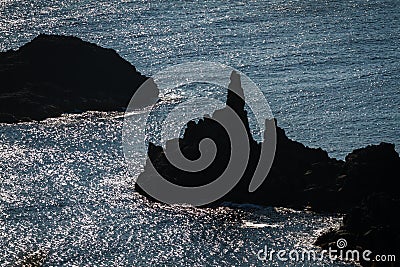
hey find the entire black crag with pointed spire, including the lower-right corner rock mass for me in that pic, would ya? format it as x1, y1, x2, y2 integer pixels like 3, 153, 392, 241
136, 70, 400, 266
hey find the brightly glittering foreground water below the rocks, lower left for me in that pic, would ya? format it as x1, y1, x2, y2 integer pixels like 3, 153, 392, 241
0, 112, 350, 266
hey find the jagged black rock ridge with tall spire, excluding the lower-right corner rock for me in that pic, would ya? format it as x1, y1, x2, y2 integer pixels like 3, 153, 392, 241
137, 73, 400, 211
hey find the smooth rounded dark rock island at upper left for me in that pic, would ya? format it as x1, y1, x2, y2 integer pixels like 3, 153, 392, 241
0, 34, 158, 123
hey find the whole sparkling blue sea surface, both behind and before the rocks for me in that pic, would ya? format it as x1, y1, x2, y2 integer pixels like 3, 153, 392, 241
0, 0, 400, 266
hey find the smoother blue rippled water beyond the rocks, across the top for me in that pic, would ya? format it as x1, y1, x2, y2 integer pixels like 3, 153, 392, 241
0, 0, 400, 158
